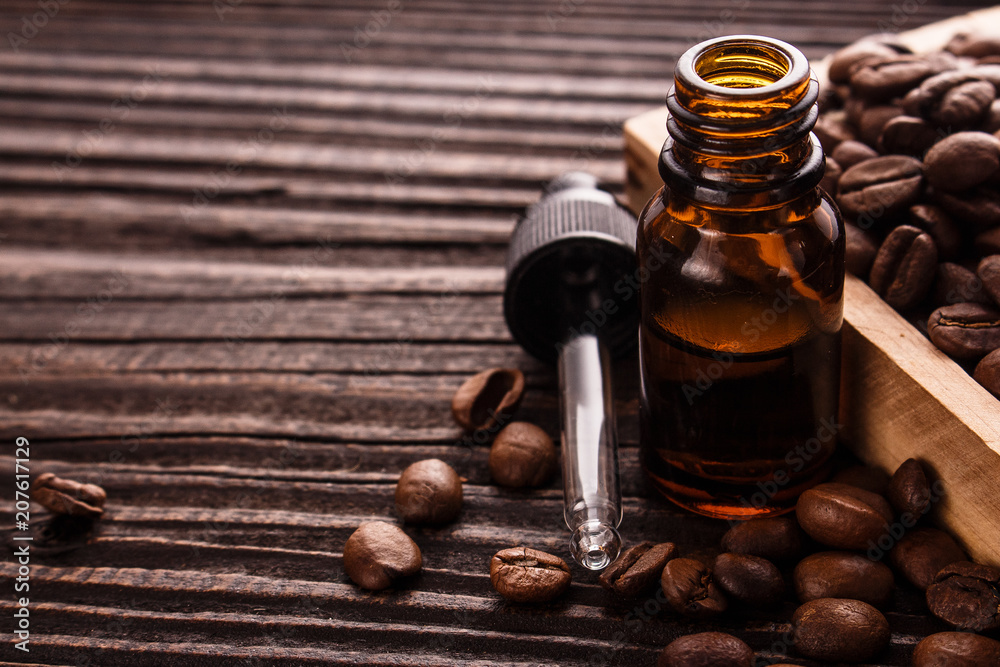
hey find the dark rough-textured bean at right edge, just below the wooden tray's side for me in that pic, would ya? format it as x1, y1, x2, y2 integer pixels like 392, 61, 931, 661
927, 561, 1000, 632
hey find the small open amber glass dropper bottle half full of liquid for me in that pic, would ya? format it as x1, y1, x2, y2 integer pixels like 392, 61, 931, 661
637, 36, 844, 518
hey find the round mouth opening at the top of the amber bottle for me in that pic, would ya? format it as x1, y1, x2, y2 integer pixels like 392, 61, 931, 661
694, 41, 792, 88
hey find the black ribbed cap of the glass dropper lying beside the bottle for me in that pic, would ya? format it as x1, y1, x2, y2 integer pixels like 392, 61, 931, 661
504, 172, 639, 362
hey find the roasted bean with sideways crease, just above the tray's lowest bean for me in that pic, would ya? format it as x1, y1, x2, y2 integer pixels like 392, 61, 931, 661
927, 303, 1000, 361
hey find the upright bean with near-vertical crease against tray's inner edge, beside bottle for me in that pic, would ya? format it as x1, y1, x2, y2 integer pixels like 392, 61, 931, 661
869, 225, 938, 310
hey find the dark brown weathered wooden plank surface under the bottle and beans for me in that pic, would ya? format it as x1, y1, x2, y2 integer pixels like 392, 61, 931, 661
0, 0, 1000, 667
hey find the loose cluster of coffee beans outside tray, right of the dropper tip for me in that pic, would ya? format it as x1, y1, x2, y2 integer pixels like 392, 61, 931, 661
652, 459, 1000, 667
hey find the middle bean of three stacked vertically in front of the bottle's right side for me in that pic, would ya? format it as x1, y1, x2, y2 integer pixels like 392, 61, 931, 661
792, 551, 896, 607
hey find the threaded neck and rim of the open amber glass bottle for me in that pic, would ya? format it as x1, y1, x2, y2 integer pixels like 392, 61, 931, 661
659, 36, 825, 208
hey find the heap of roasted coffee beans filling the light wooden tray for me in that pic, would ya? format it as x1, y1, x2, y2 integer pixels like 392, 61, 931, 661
815, 35, 1000, 397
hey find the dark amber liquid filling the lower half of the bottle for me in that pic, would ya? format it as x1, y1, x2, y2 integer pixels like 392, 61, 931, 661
640, 326, 839, 518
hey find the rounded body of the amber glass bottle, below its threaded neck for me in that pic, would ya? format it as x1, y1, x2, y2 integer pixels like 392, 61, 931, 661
640, 193, 842, 518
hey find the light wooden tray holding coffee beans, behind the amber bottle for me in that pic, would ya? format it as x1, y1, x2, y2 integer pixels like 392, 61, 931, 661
625, 7, 1000, 566
